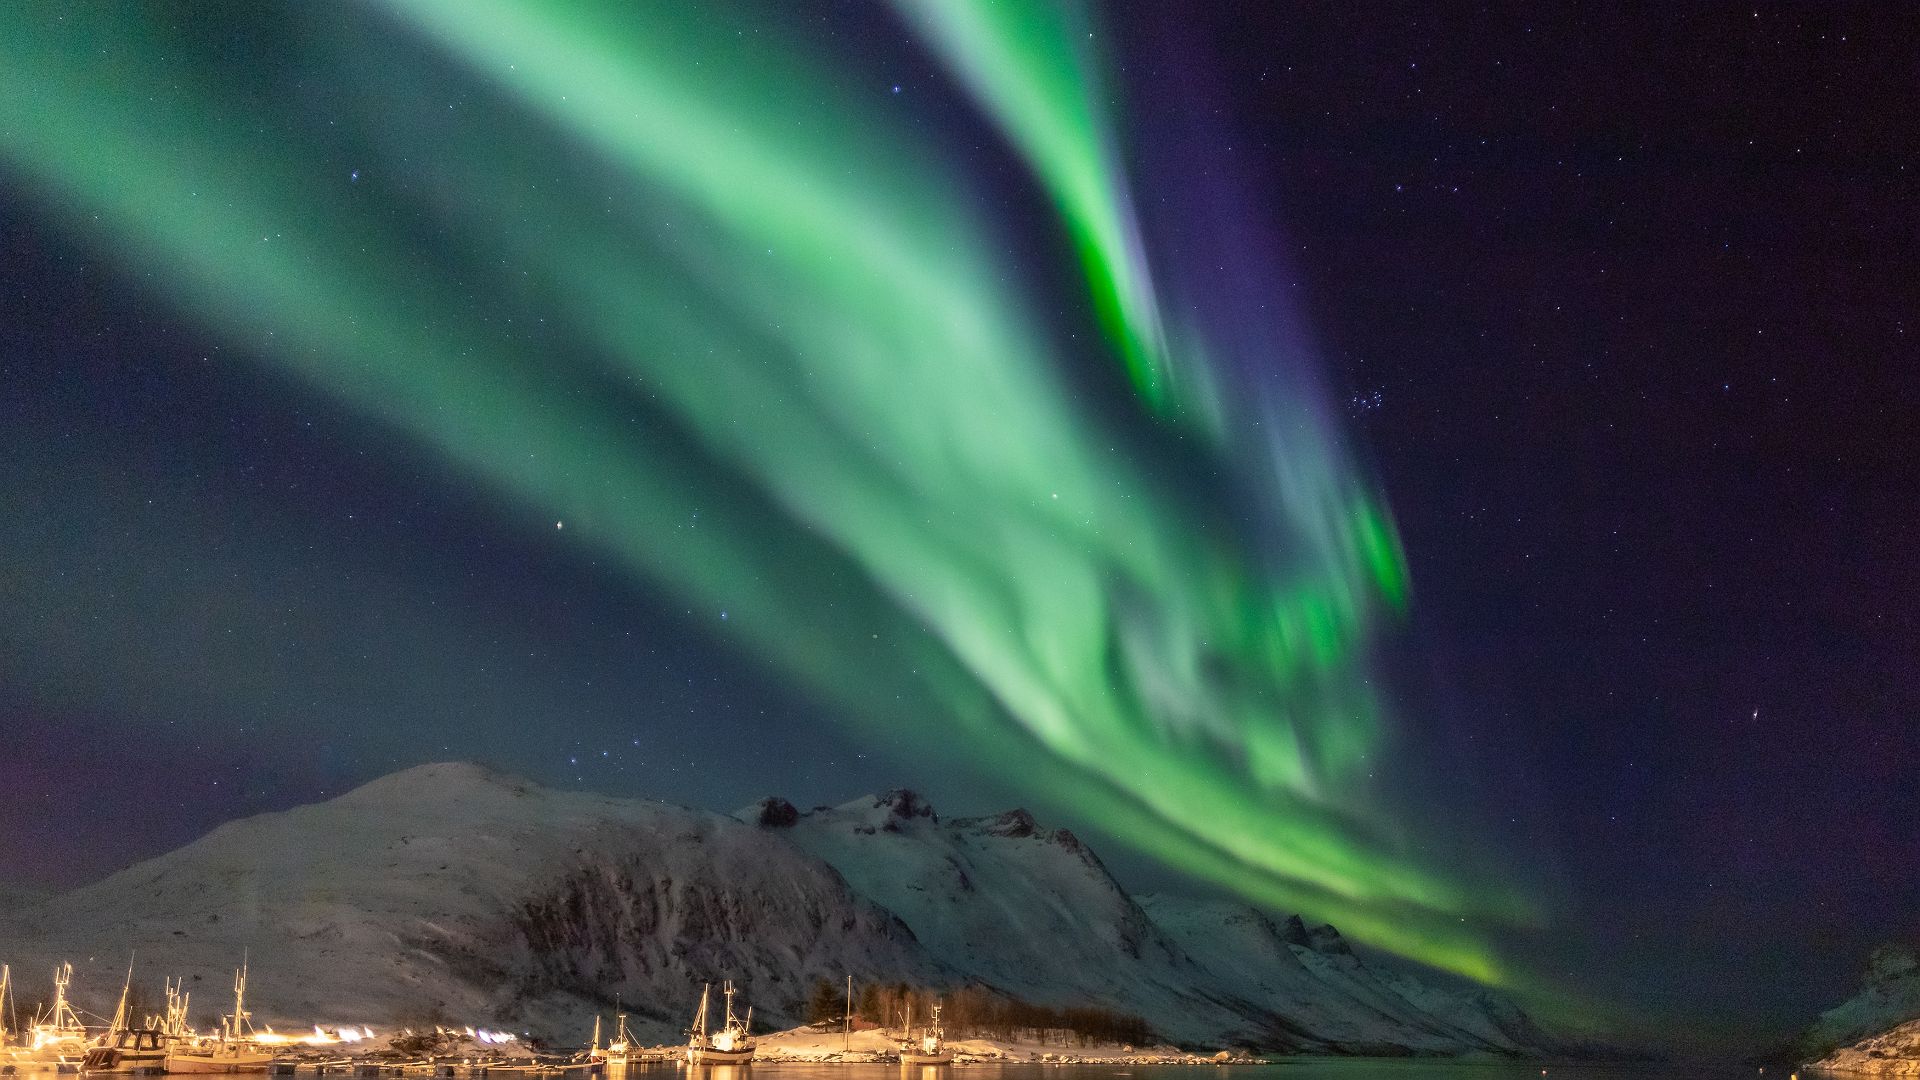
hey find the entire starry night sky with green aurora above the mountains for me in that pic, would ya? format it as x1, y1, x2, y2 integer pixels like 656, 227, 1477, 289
0, 2, 1920, 1049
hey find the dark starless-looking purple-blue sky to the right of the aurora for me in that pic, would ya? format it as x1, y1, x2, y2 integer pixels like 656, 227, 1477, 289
1190, 6, 1920, 1026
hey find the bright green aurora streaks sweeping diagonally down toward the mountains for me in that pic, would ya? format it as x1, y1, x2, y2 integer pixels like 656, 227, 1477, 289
0, 0, 1532, 984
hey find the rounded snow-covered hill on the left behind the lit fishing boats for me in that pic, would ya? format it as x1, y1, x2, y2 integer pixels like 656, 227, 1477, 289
0, 765, 936, 1042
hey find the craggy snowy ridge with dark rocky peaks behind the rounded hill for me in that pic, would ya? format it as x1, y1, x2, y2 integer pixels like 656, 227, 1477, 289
737, 792, 1557, 1053
